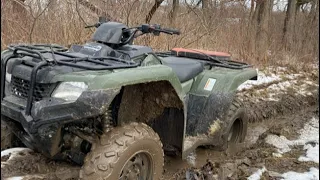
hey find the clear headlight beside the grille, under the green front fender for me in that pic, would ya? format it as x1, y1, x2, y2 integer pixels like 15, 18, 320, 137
51, 82, 88, 101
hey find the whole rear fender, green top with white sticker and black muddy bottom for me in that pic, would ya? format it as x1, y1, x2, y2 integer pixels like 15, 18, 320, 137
182, 68, 257, 158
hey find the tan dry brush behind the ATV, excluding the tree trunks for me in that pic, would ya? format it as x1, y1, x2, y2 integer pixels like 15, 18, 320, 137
1, 0, 319, 67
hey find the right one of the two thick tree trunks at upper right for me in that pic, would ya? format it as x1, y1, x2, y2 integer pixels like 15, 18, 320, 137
282, 0, 296, 50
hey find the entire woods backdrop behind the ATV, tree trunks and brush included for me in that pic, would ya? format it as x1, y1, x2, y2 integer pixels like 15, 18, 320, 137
1, 0, 319, 67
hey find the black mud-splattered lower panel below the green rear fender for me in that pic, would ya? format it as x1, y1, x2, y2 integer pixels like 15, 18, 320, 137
182, 92, 234, 158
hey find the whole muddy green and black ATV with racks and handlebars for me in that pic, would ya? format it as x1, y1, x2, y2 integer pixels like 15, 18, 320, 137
1, 17, 257, 180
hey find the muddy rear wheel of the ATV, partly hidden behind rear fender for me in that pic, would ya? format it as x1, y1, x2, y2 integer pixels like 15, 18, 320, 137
216, 99, 248, 151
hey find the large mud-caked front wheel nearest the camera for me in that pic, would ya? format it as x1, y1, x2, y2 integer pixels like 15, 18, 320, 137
80, 123, 164, 180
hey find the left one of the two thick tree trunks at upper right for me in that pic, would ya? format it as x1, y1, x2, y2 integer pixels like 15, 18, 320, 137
252, 0, 273, 61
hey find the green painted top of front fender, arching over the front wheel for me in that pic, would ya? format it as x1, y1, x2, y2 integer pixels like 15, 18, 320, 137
53, 65, 186, 99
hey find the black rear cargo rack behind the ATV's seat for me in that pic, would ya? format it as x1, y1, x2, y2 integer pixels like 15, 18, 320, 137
156, 50, 252, 69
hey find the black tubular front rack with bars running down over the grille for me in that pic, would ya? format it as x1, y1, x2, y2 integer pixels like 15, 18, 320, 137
1, 44, 140, 115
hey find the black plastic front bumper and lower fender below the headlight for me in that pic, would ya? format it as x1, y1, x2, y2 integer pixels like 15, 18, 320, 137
1, 88, 120, 133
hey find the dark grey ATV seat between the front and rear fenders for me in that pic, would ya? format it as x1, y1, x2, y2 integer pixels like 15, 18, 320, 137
162, 56, 204, 83
